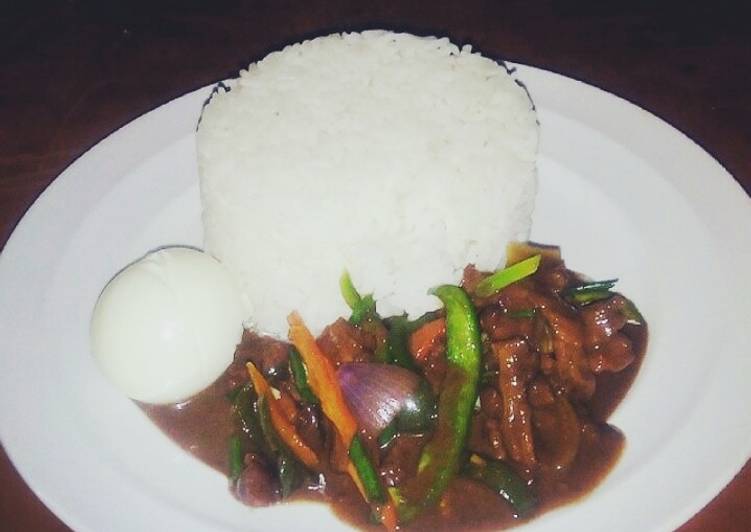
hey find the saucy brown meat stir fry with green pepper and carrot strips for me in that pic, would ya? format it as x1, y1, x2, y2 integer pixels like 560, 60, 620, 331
144, 244, 646, 530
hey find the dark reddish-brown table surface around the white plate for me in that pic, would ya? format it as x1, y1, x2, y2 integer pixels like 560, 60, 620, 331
0, 0, 751, 531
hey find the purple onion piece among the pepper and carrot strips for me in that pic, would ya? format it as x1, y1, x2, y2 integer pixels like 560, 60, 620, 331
337, 362, 420, 436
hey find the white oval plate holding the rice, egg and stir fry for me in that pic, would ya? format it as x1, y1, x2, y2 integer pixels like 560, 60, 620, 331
0, 66, 751, 531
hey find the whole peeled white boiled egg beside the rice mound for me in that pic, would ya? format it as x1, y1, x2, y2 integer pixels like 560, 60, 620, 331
91, 247, 246, 404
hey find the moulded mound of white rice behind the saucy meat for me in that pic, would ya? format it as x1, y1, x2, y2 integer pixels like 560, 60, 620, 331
198, 31, 538, 336
